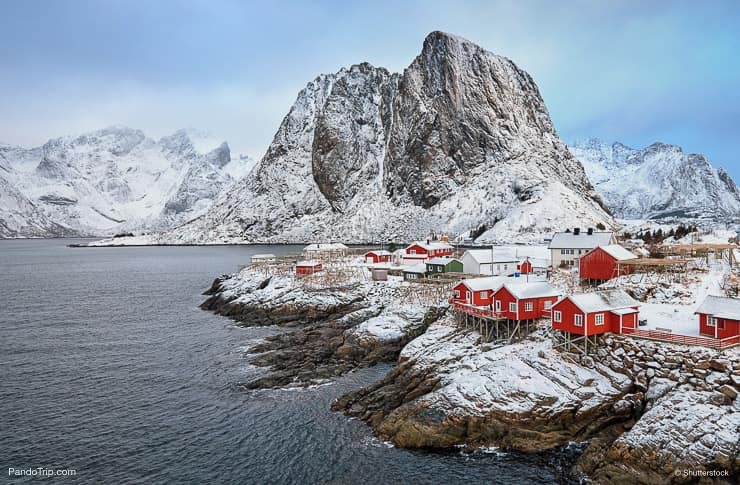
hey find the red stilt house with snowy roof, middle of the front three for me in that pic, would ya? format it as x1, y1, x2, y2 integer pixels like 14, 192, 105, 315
493, 281, 559, 320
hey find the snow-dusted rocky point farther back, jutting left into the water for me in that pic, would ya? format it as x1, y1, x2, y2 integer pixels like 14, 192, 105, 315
201, 269, 446, 389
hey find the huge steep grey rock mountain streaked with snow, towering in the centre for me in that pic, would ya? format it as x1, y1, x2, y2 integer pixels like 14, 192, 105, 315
153, 32, 613, 243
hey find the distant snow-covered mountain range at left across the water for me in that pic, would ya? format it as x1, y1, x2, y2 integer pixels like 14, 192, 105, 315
0, 126, 252, 237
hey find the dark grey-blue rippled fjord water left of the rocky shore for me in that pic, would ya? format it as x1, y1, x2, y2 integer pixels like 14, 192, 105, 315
0, 240, 562, 484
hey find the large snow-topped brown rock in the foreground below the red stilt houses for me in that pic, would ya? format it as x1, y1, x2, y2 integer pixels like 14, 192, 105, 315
333, 323, 634, 451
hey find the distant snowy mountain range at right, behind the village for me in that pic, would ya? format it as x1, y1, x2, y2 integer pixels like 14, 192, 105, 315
570, 138, 740, 220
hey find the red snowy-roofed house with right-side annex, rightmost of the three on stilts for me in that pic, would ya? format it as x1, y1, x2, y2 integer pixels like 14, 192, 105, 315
552, 290, 640, 335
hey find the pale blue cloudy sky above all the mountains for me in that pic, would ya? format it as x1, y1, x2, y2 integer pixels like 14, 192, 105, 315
0, 0, 740, 179
